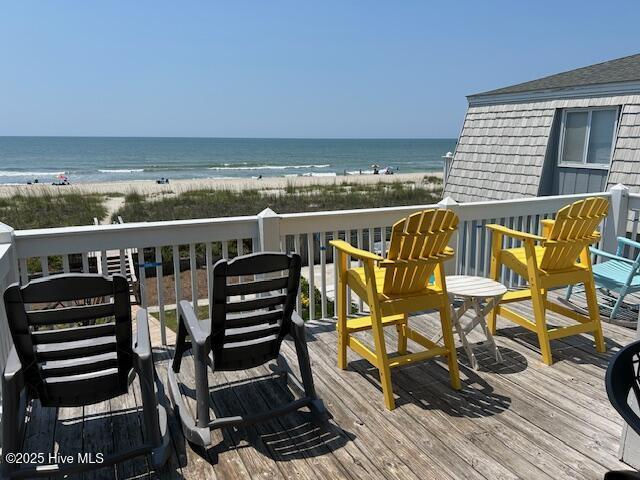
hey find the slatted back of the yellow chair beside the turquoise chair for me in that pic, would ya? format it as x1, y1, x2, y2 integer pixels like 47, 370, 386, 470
540, 197, 609, 271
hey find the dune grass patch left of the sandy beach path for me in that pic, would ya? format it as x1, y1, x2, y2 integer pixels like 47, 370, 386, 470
0, 191, 107, 230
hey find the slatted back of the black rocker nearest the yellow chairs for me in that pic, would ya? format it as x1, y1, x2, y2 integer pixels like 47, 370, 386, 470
210, 253, 301, 370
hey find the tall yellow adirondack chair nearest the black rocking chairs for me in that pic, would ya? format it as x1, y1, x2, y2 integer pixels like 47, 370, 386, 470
330, 209, 460, 410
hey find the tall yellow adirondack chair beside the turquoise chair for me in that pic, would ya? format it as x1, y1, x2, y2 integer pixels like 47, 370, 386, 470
487, 197, 609, 365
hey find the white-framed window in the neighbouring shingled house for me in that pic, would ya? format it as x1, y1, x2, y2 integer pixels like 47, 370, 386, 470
558, 108, 618, 167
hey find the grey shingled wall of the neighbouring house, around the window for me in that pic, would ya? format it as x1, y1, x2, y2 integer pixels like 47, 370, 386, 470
444, 95, 640, 202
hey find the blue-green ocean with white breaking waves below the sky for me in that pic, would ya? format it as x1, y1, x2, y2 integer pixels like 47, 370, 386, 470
0, 137, 456, 184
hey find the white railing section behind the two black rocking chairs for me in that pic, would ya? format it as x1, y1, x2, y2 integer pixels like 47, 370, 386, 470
15, 216, 258, 344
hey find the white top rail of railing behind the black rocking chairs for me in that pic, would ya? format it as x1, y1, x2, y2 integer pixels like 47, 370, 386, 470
15, 216, 258, 258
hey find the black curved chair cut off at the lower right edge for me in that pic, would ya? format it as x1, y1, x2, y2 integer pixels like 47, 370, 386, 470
604, 341, 640, 480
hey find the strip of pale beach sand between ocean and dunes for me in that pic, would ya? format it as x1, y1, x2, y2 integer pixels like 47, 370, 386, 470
0, 172, 442, 198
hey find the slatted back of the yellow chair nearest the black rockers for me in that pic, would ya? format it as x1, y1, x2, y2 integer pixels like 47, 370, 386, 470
381, 209, 458, 295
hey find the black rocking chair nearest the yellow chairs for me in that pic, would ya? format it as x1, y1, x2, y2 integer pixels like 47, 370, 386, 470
169, 253, 326, 447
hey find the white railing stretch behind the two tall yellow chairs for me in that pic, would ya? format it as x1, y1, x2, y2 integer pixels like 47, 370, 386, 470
269, 188, 612, 318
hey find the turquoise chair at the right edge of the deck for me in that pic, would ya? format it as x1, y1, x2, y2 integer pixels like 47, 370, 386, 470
566, 237, 640, 318
